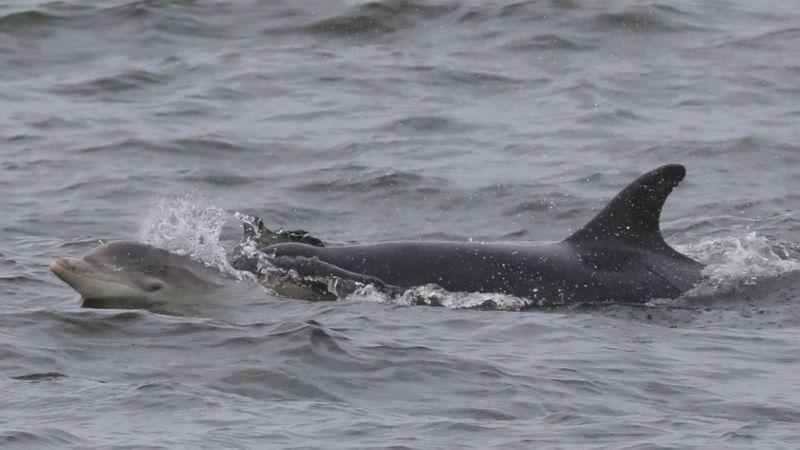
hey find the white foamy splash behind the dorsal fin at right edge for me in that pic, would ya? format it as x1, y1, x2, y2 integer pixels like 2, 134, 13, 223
677, 232, 800, 296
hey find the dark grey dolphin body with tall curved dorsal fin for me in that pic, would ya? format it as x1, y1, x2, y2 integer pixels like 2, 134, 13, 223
241, 164, 703, 305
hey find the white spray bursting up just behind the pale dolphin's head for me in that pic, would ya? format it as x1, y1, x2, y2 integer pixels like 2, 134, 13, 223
139, 192, 238, 275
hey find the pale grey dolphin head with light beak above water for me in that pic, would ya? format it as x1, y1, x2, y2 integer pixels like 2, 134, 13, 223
50, 241, 221, 309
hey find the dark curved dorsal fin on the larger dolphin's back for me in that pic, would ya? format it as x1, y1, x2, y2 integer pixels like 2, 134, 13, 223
566, 164, 686, 249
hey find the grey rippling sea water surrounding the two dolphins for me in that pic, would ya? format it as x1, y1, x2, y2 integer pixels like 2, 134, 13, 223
0, 0, 800, 449
